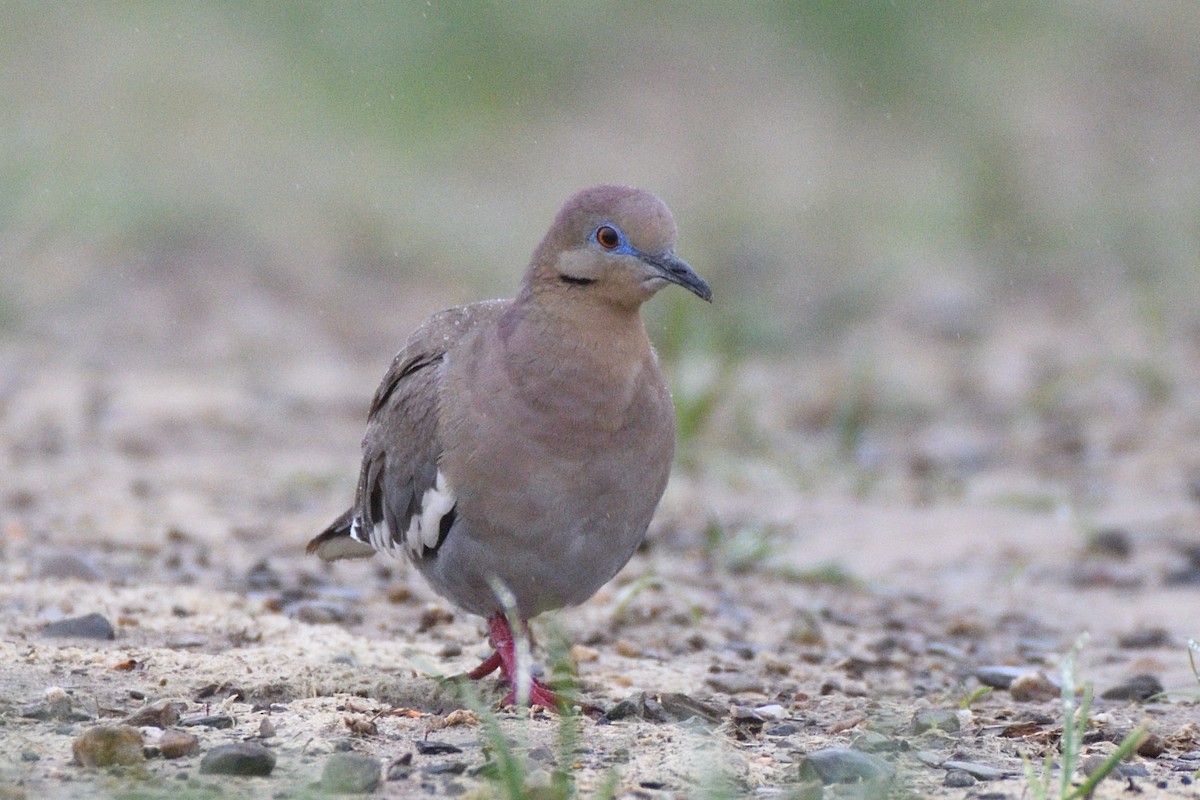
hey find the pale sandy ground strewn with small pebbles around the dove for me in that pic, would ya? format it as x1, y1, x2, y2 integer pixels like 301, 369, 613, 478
0, 248, 1200, 799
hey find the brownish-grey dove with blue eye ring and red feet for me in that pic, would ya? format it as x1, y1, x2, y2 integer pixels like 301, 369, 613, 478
308, 186, 712, 708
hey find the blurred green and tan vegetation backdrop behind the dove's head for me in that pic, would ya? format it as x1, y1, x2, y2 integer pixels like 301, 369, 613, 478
0, 0, 1200, 355
